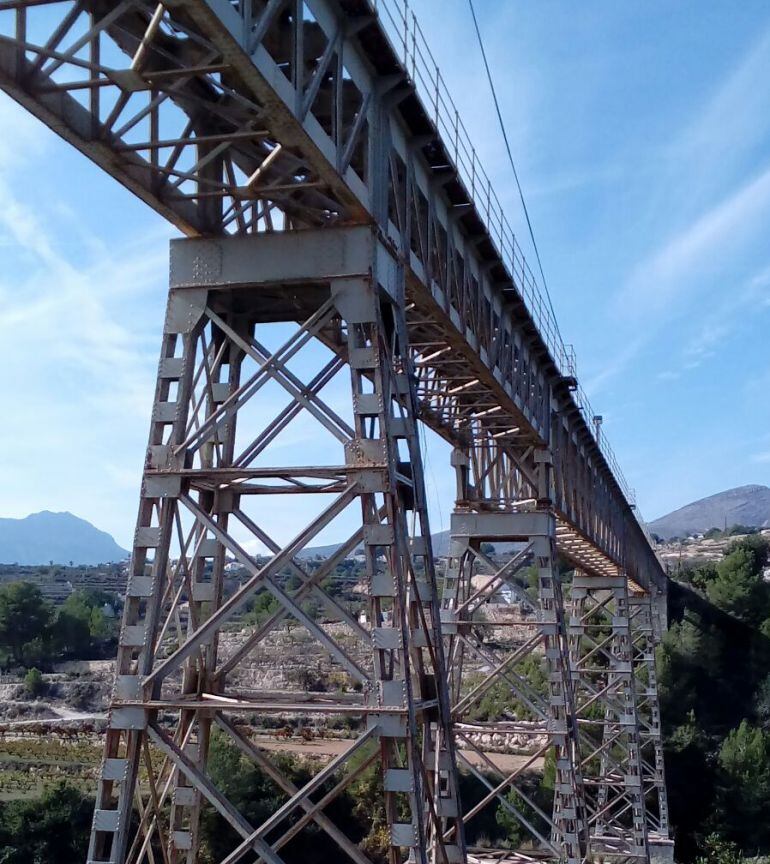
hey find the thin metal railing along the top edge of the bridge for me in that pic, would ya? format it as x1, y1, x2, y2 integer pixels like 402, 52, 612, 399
369, 0, 643, 510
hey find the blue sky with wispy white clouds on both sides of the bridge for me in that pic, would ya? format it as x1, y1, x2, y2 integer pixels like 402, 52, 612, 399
0, 0, 770, 545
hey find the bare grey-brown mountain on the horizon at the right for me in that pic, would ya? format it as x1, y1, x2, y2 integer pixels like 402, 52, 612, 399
647, 486, 770, 540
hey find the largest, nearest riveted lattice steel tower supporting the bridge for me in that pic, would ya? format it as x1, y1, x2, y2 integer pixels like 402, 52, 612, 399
89, 233, 465, 864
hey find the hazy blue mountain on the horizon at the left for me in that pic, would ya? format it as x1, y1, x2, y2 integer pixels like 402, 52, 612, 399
0, 510, 128, 565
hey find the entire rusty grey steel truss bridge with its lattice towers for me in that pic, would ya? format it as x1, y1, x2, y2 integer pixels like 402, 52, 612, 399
0, 0, 671, 864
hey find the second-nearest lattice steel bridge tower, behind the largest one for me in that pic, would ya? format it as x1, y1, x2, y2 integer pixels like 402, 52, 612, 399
442, 439, 588, 862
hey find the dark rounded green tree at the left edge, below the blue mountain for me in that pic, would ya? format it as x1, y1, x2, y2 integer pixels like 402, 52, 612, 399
0, 582, 52, 666
